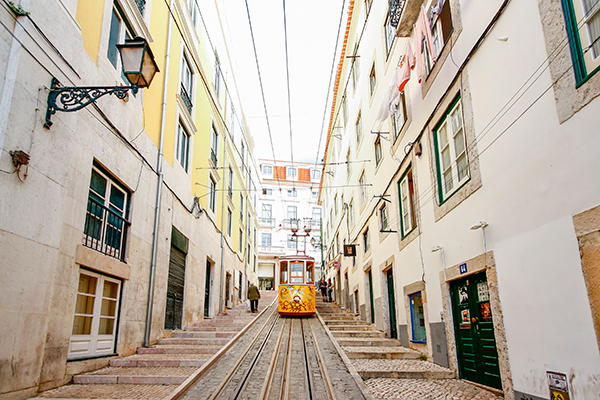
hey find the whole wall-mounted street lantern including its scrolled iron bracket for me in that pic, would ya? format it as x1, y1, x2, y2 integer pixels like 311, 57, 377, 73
44, 36, 159, 129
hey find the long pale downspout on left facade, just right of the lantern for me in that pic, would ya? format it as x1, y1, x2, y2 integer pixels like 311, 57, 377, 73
144, 0, 173, 347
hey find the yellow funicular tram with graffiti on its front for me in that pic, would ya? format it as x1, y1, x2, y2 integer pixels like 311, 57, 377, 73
276, 219, 315, 316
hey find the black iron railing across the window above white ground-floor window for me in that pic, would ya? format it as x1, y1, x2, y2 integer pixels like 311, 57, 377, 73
83, 198, 131, 261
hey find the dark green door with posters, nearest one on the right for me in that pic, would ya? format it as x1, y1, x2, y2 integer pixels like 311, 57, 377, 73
450, 272, 502, 389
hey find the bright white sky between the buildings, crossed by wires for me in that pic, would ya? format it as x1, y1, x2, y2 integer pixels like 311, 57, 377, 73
221, 0, 348, 163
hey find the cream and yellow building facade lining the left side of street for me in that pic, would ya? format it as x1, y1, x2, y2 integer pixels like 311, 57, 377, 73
0, 0, 258, 399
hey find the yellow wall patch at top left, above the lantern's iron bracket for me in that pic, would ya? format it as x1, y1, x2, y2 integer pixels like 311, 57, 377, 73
75, 0, 104, 64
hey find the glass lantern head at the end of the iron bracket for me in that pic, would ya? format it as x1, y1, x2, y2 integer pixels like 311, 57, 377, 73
117, 36, 158, 88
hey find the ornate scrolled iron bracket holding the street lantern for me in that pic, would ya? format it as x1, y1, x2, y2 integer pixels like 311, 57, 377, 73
44, 78, 138, 129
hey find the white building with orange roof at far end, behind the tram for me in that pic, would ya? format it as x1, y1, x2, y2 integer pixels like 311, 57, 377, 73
257, 159, 323, 290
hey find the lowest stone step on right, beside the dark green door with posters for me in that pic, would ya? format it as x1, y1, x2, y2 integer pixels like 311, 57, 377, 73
352, 360, 456, 379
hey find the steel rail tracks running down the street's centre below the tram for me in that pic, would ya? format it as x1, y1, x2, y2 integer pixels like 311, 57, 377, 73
185, 307, 337, 400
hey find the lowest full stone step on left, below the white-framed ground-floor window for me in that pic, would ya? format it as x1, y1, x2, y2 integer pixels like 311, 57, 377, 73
73, 367, 197, 385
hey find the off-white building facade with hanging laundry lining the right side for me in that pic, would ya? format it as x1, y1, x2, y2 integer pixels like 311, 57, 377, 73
320, 0, 600, 399
